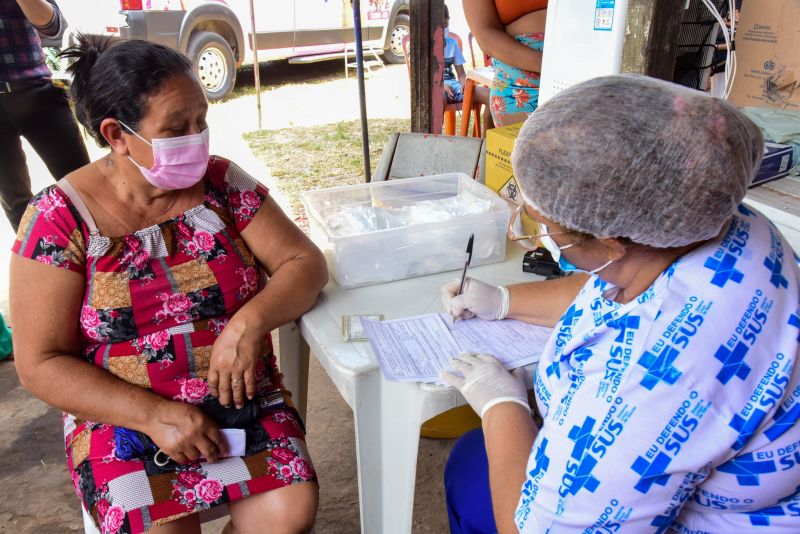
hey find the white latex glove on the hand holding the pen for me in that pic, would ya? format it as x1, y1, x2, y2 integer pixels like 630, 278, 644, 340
441, 277, 509, 321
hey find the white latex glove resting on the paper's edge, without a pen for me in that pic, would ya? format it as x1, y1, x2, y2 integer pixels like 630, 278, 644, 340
440, 352, 531, 418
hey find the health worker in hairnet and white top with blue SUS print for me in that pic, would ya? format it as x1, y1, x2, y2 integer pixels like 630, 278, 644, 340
443, 76, 800, 534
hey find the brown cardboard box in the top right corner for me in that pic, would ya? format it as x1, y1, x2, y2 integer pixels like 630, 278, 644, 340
729, 0, 800, 110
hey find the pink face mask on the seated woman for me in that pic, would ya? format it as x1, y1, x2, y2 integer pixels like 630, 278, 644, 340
119, 121, 209, 190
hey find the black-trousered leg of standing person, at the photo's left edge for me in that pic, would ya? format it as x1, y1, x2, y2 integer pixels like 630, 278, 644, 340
0, 93, 32, 232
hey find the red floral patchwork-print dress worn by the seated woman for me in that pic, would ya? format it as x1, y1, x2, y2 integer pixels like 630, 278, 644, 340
13, 156, 316, 534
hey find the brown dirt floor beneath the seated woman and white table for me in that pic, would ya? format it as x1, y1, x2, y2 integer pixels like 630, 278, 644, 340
0, 356, 452, 534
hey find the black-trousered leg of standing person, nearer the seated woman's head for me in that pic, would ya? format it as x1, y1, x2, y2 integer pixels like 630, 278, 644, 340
20, 84, 89, 186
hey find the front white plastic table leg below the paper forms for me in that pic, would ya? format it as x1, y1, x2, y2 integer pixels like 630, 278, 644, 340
353, 371, 422, 534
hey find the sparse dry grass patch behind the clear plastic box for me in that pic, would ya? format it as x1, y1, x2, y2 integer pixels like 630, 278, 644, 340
244, 119, 410, 231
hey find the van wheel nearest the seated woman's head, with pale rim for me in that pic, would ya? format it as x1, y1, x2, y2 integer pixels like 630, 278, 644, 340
186, 32, 236, 102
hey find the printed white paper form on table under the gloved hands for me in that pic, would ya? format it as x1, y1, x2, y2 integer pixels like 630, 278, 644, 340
361, 314, 552, 383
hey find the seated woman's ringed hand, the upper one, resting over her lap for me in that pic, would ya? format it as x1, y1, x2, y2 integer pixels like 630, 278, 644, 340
208, 316, 265, 408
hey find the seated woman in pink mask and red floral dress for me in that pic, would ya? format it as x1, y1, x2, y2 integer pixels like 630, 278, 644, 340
11, 38, 327, 534
